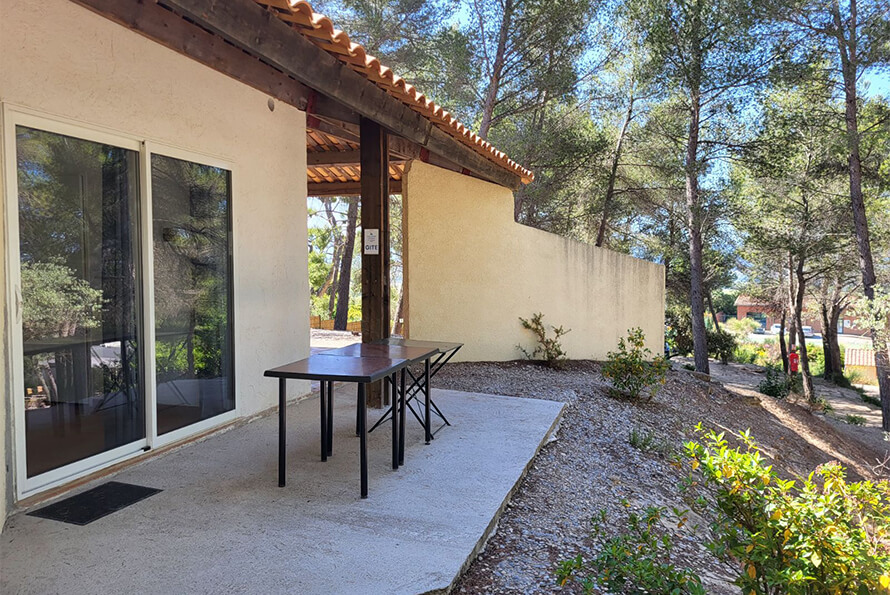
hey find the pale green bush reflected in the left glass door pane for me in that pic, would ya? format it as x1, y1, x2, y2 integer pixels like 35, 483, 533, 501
22, 261, 102, 340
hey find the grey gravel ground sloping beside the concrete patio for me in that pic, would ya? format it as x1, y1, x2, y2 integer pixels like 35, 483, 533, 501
434, 361, 880, 595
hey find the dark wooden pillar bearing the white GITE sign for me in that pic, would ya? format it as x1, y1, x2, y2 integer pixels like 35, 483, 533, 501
360, 118, 390, 407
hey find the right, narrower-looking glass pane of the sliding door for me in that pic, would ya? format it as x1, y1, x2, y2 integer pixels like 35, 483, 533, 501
151, 155, 235, 435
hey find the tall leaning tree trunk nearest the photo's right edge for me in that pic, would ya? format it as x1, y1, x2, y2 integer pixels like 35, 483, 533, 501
831, 0, 890, 432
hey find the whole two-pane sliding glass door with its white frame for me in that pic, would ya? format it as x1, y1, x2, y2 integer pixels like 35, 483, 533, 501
7, 108, 237, 498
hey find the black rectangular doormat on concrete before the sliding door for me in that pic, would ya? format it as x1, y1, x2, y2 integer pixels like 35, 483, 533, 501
28, 481, 161, 525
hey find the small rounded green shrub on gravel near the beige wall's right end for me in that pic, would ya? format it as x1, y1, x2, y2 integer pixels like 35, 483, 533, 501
602, 328, 670, 401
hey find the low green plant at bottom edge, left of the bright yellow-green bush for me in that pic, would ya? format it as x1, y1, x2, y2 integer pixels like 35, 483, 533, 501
556, 506, 705, 595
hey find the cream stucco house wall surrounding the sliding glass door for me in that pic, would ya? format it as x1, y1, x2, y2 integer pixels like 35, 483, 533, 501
0, 0, 309, 520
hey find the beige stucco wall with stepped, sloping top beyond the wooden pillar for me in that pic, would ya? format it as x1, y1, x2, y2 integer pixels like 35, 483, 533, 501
403, 161, 664, 361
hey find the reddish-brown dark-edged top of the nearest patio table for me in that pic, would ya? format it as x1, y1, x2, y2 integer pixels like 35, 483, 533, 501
264, 354, 411, 382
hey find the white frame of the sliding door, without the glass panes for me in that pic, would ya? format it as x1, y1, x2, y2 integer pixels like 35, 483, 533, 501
0, 103, 241, 500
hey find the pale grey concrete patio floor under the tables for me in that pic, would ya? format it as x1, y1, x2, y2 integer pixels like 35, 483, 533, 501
0, 388, 563, 595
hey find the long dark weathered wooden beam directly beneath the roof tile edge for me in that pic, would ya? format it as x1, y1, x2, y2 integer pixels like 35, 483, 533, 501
159, 0, 521, 189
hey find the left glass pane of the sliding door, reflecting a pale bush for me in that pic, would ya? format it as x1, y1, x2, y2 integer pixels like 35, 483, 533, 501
16, 126, 145, 477
